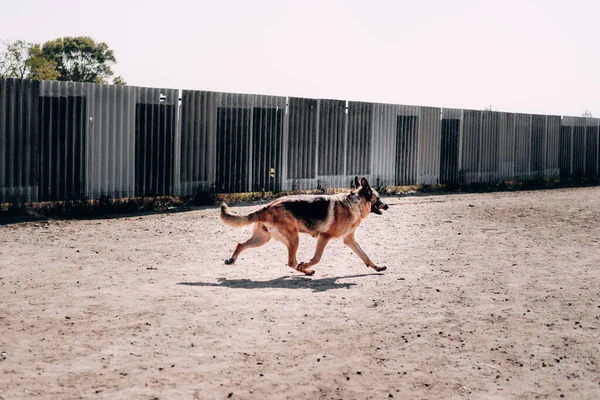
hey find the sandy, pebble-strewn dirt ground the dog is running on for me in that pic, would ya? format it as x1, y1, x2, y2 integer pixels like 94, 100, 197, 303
0, 188, 600, 399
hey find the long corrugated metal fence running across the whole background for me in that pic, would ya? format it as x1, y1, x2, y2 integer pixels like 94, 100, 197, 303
0, 79, 600, 202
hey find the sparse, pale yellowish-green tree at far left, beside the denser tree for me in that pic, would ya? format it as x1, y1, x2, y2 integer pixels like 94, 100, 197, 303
0, 40, 60, 80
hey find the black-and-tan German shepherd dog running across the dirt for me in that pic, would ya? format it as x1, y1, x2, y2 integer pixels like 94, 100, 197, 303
221, 177, 388, 275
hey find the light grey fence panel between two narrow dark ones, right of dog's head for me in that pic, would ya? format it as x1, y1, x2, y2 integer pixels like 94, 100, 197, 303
417, 107, 442, 185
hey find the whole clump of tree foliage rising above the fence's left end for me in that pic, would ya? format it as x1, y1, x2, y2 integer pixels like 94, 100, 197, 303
0, 36, 126, 85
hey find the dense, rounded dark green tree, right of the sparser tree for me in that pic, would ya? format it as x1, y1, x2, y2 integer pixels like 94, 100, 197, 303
41, 36, 117, 83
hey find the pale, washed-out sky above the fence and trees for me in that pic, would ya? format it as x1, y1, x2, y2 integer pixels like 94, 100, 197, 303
0, 0, 600, 117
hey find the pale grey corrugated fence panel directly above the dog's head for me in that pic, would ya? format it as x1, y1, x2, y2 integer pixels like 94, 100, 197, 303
369, 103, 398, 186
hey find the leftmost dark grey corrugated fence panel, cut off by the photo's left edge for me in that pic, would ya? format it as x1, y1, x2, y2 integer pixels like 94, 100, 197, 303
0, 79, 39, 203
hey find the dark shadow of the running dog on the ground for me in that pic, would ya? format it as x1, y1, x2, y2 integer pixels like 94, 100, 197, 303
178, 273, 383, 292
